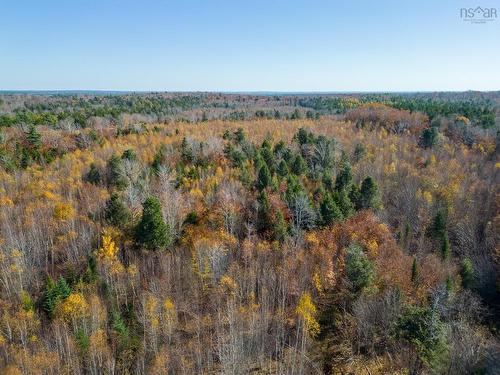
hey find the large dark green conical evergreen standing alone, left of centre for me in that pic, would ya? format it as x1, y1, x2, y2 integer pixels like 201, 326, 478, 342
135, 197, 172, 250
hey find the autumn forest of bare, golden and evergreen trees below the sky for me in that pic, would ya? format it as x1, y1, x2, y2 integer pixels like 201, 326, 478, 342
0, 92, 500, 375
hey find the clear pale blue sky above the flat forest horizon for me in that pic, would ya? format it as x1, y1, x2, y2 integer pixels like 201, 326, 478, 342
0, 0, 500, 92
